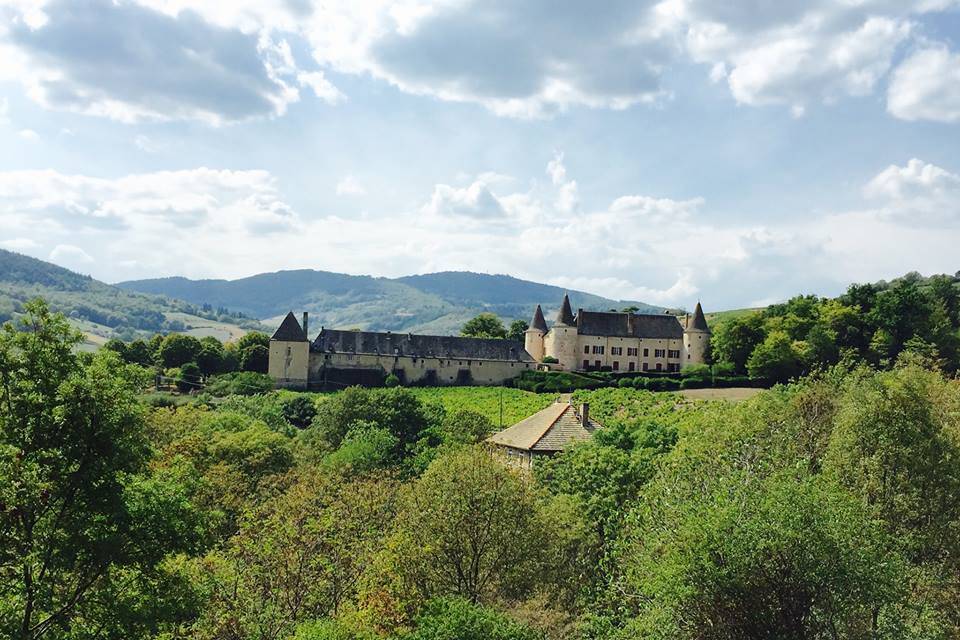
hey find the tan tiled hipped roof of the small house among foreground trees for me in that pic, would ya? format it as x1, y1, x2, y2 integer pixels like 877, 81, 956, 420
487, 402, 601, 453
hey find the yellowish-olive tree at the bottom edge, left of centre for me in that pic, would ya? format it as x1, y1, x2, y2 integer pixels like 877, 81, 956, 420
200, 470, 395, 640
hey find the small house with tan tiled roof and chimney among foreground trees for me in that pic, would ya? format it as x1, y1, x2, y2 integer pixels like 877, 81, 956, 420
487, 401, 601, 469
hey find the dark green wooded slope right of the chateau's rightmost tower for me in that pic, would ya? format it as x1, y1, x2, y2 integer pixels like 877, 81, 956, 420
711, 273, 960, 382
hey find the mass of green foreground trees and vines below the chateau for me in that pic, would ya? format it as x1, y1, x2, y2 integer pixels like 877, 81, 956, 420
0, 302, 960, 640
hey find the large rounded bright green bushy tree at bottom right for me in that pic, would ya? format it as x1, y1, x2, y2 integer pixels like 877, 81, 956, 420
626, 472, 906, 640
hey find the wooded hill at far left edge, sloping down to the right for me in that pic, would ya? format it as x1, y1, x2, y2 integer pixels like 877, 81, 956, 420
0, 249, 263, 345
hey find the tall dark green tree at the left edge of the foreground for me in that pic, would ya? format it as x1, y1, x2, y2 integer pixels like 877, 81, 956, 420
0, 301, 195, 640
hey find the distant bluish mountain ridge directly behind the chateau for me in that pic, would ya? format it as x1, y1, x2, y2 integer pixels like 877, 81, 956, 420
116, 269, 663, 335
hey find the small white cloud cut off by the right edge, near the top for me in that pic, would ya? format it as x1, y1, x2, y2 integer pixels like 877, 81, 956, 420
887, 46, 960, 122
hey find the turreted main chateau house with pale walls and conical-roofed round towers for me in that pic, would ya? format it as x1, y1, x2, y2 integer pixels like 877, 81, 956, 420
524, 296, 710, 372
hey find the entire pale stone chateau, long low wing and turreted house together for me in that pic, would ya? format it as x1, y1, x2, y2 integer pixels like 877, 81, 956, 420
269, 296, 710, 389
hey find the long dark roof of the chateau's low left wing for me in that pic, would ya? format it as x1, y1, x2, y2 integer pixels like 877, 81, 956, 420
311, 329, 534, 362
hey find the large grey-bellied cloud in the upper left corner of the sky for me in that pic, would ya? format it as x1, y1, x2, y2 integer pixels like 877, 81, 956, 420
0, 0, 338, 124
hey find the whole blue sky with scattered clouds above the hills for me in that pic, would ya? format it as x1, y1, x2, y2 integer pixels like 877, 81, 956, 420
0, 0, 960, 310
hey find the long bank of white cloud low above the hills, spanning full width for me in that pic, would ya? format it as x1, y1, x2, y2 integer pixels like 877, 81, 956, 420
0, 160, 960, 309
